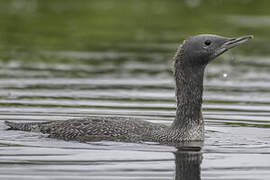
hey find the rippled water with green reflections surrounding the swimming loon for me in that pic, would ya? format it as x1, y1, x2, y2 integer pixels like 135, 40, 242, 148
0, 0, 270, 180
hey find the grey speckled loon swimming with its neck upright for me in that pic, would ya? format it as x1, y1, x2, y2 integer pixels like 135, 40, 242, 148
5, 34, 253, 144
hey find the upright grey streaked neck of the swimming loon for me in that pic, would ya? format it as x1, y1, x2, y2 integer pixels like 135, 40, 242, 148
171, 47, 205, 130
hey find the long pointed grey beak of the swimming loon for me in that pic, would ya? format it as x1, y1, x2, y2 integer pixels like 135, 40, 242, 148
215, 35, 253, 57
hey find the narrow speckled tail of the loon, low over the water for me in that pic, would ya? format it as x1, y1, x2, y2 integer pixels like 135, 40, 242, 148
5, 121, 48, 131
